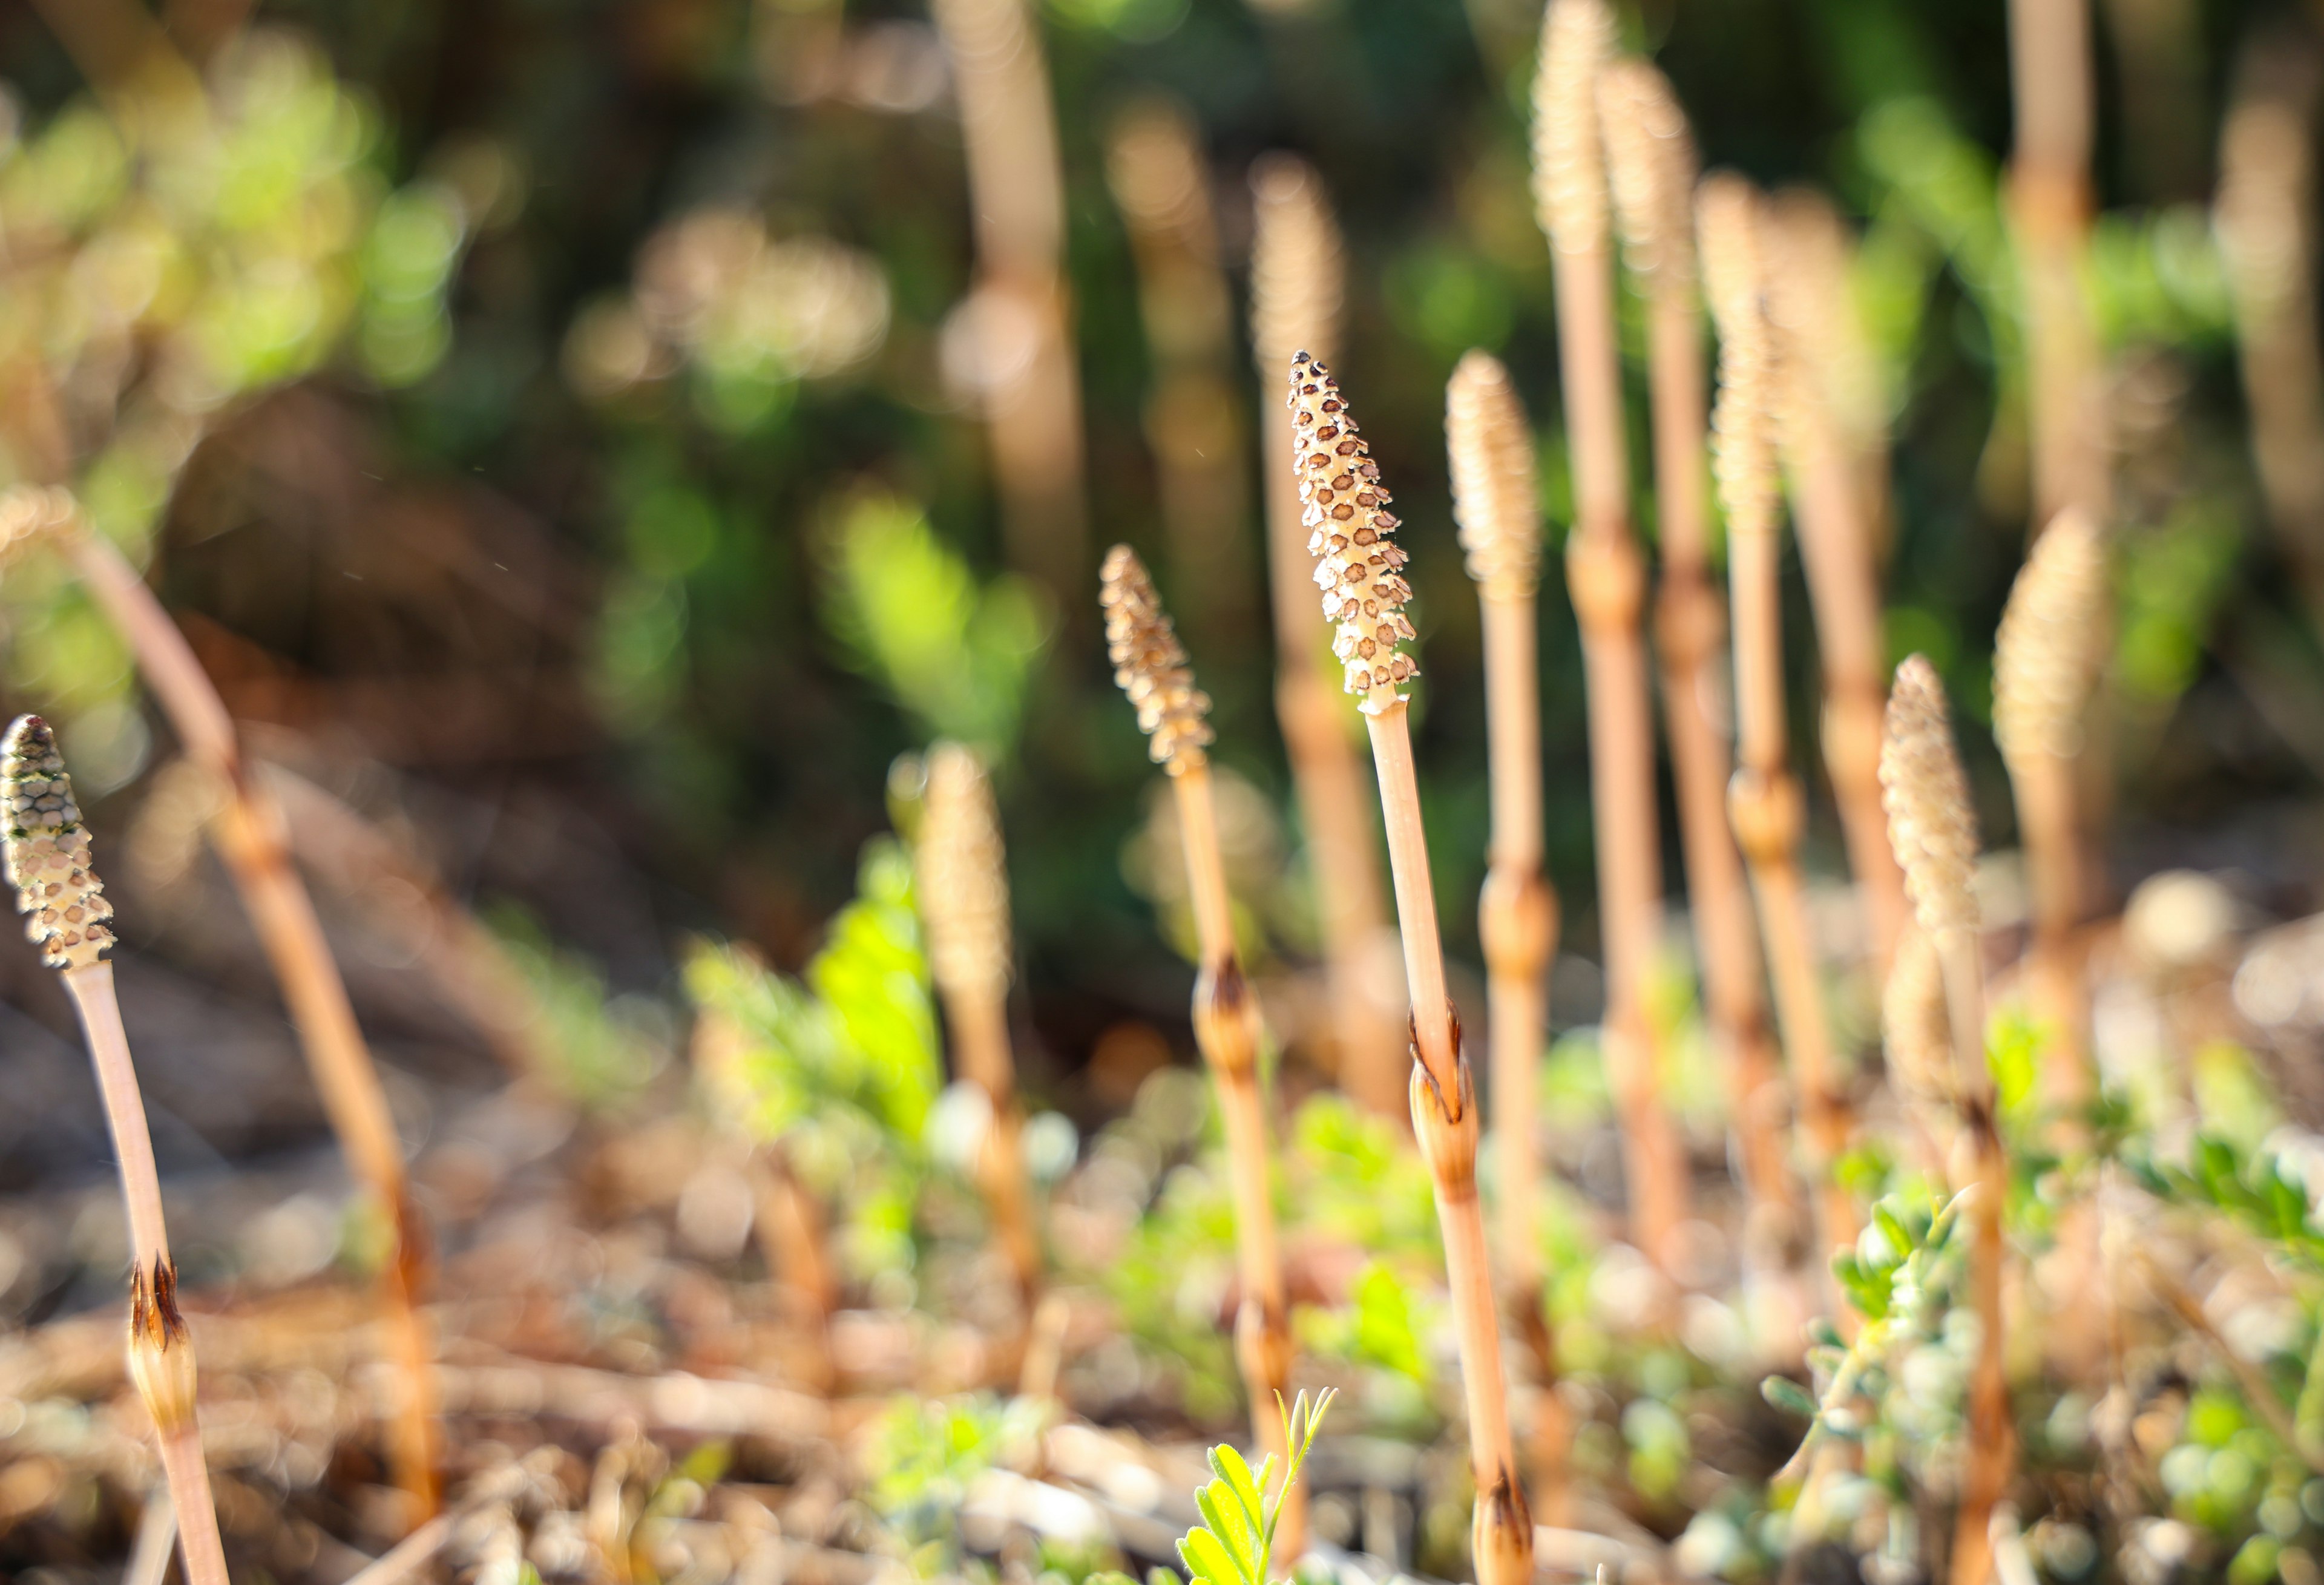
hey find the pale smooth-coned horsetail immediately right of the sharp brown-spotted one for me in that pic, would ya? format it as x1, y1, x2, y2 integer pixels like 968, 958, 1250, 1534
1445, 351, 1566, 1518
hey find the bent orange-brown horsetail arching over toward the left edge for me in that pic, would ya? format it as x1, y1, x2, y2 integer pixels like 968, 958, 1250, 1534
0, 488, 439, 1518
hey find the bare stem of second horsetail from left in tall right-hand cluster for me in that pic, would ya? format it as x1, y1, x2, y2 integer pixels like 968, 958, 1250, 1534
1648, 269, 1794, 1206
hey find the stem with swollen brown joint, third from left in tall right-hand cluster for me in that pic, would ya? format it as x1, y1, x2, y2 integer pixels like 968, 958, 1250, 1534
1727, 511, 1857, 1269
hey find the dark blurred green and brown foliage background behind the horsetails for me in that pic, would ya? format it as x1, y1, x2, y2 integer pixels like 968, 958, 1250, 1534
0, 0, 2296, 1183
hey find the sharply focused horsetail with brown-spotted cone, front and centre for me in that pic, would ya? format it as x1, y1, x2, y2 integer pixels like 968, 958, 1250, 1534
1290, 351, 1534, 1585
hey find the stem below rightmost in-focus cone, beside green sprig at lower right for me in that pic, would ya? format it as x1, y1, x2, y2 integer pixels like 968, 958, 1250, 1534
1936, 927, 2017, 1585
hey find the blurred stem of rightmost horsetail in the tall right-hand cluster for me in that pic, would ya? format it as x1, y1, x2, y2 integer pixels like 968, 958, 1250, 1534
1792, 402, 1906, 976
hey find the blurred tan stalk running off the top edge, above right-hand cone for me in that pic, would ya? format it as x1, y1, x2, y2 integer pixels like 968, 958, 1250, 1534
2011, 0, 2113, 528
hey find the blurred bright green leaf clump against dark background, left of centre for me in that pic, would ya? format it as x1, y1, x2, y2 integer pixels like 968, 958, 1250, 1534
822, 495, 1053, 763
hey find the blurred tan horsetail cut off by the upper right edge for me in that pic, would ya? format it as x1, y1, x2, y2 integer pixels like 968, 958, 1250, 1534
2215, 61, 2324, 611
